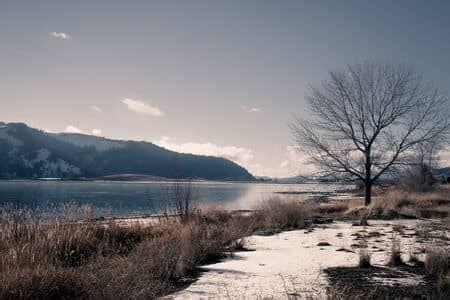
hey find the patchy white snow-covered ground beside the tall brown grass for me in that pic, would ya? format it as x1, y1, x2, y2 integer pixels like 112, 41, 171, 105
166, 220, 442, 299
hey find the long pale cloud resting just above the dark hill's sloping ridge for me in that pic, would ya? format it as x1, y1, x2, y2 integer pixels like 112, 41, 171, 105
154, 137, 253, 165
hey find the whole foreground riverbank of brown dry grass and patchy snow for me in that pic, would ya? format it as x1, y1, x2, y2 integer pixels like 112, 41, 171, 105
0, 187, 450, 299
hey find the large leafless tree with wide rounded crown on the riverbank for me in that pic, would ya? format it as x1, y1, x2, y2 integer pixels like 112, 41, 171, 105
292, 63, 450, 205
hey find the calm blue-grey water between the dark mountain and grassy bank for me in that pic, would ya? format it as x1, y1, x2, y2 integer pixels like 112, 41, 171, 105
0, 181, 348, 217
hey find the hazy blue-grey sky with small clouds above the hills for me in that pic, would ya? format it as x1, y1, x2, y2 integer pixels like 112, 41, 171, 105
0, 0, 450, 177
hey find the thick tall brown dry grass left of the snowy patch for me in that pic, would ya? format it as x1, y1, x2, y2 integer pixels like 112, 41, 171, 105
0, 201, 313, 299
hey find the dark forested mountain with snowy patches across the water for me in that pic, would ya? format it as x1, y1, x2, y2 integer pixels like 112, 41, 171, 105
0, 122, 254, 180
